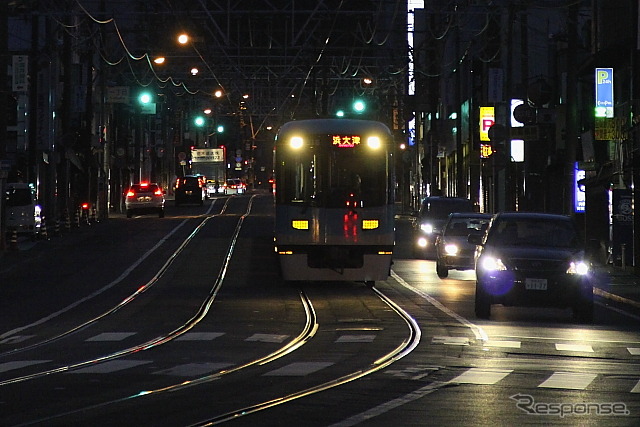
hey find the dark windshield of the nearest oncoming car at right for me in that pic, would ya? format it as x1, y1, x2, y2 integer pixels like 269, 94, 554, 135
487, 218, 580, 248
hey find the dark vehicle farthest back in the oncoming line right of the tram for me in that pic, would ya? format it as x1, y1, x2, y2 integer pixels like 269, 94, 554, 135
413, 196, 475, 258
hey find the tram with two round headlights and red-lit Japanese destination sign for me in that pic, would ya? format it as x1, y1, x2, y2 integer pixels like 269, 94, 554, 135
274, 119, 395, 284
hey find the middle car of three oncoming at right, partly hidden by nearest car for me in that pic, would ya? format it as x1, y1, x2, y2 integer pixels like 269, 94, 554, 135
435, 213, 493, 279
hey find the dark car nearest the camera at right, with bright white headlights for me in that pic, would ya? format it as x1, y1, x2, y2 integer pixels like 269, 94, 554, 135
468, 212, 594, 323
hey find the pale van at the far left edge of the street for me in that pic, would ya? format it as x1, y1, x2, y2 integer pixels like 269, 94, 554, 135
3, 182, 42, 238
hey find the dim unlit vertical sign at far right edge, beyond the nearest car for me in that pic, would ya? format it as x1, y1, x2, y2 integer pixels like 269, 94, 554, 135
611, 189, 633, 265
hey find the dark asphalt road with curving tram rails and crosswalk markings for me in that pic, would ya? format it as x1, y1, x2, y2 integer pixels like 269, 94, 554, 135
0, 194, 640, 426
